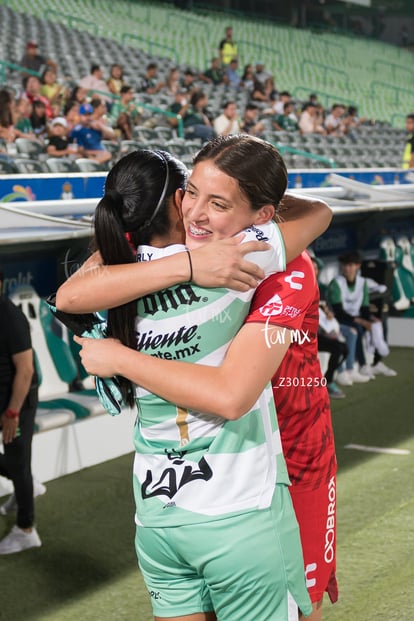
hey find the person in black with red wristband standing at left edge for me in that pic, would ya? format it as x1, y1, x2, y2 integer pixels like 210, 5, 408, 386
0, 269, 46, 554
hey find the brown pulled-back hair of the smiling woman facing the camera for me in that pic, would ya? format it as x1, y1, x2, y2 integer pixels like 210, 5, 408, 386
193, 134, 288, 211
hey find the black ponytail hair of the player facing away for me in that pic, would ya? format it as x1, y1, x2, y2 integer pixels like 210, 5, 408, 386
94, 149, 187, 406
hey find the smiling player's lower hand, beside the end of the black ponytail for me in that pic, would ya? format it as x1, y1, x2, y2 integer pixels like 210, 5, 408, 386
73, 336, 124, 377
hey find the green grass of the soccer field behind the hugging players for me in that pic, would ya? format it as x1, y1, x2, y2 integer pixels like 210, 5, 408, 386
0, 348, 414, 621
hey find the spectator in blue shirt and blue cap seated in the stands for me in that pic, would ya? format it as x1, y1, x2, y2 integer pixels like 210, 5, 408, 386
70, 103, 114, 164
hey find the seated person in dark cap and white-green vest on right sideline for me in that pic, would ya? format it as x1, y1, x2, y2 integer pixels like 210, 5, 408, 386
327, 252, 389, 386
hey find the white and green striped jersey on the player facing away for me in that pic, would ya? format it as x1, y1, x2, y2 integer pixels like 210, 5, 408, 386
134, 222, 288, 526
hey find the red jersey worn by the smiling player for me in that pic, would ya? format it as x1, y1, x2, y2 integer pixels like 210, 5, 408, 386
246, 252, 336, 489
